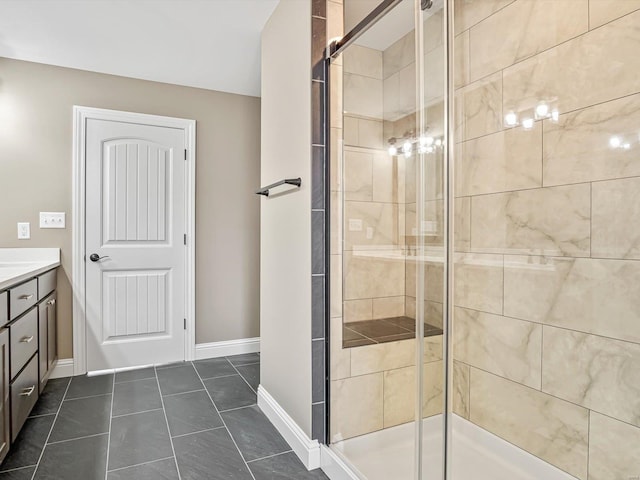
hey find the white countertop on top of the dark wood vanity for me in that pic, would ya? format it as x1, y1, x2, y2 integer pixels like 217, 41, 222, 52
0, 248, 60, 290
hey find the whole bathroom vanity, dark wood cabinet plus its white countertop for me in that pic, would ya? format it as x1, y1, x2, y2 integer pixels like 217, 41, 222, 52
0, 248, 60, 462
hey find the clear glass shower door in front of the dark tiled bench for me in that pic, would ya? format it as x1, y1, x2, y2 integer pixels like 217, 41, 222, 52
330, 0, 447, 480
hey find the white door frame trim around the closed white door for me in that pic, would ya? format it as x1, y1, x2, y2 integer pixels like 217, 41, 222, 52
71, 105, 196, 375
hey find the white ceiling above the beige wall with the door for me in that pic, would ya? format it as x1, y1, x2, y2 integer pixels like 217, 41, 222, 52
0, 0, 279, 96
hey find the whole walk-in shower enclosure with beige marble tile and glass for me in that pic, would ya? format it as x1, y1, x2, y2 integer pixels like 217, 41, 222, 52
328, 0, 640, 480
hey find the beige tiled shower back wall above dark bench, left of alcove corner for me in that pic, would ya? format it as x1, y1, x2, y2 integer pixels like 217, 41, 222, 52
342, 45, 405, 322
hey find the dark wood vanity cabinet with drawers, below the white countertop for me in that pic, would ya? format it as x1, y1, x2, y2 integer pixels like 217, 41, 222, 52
0, 269, 57, 448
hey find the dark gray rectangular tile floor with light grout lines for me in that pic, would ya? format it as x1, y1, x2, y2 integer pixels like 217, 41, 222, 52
0, 353, 327, 480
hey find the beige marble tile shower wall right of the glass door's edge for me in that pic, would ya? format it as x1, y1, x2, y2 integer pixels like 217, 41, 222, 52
453, 0, 640, 480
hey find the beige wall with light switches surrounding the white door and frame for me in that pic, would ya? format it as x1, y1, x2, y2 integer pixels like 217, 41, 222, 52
0, 58, 260, 358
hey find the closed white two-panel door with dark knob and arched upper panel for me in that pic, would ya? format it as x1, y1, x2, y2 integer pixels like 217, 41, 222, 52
85, 119, 187, 371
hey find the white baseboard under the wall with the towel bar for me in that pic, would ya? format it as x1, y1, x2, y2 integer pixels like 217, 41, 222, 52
258, 385, 320, 470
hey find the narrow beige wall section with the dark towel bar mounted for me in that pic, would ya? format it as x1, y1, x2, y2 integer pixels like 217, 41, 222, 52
260, 0, 311, 437
